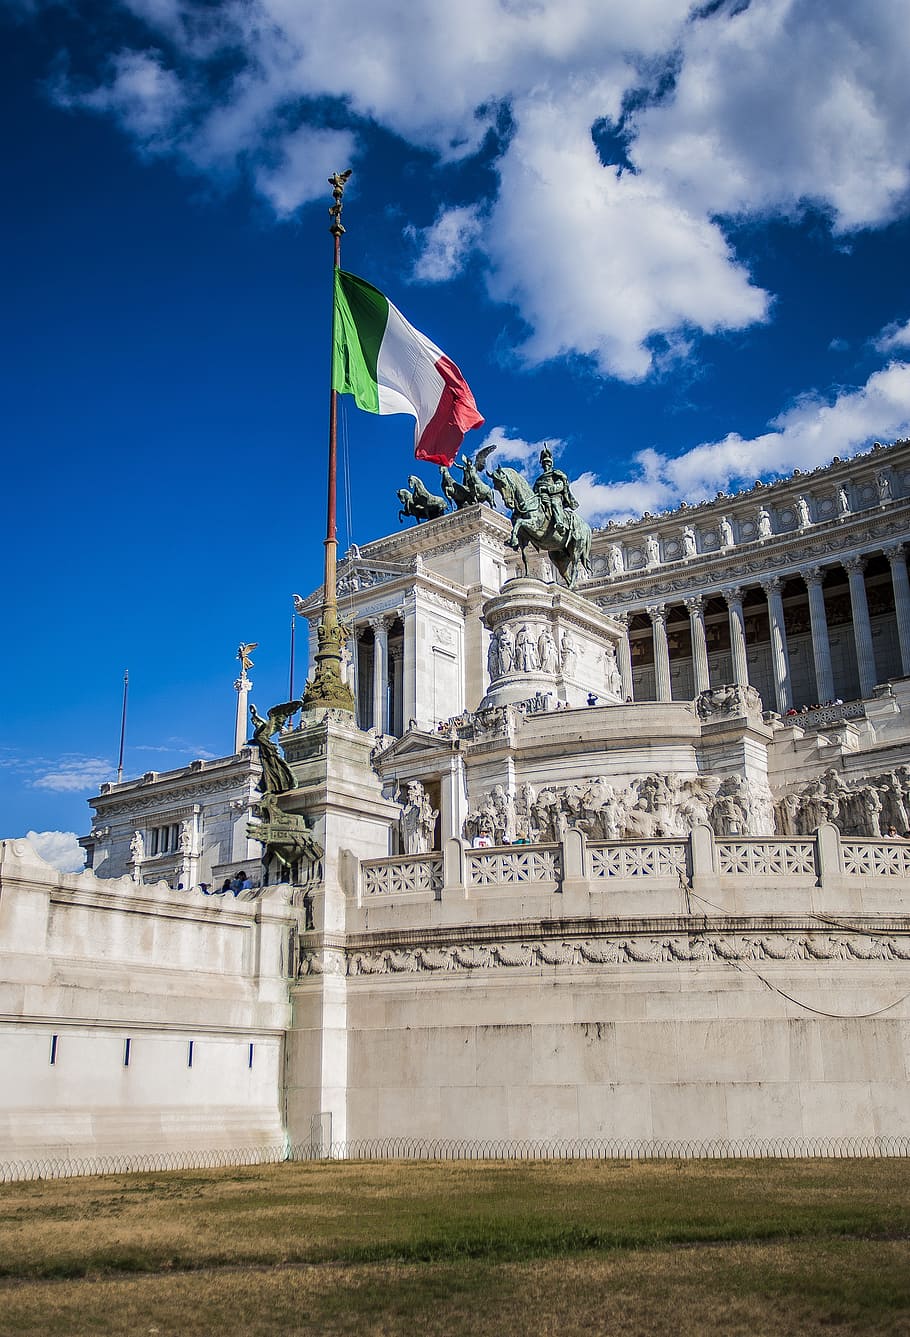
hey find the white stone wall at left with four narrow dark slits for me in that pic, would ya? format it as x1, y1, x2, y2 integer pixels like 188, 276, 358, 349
0, 841, 295, 1161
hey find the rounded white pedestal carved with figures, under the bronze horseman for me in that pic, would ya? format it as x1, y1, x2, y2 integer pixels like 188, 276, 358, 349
478, 578, 623, 710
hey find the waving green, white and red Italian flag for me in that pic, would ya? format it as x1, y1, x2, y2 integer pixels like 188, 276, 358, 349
331, 269, 484, 464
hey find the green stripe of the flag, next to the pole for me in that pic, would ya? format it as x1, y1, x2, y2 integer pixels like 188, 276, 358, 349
331, 269, 389, 413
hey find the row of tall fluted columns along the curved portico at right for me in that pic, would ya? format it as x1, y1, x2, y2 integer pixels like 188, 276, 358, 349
612, 543, 910, 714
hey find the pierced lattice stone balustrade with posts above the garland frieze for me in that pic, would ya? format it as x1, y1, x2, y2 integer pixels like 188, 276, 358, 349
350, 825, 910, 913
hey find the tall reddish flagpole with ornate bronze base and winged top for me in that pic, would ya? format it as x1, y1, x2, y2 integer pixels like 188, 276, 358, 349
303, 170, 354, 713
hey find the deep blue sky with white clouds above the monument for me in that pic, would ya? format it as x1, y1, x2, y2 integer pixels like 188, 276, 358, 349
0, 0, 910, 861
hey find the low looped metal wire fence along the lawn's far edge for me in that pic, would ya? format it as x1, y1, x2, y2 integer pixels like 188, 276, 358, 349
0, 1138, 910, 1183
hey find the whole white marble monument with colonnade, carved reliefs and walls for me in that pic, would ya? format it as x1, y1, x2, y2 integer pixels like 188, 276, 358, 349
0, 443, 910, 1171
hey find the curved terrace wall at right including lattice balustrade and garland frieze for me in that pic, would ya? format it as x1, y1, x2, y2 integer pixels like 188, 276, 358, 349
297, 828, 910, 1146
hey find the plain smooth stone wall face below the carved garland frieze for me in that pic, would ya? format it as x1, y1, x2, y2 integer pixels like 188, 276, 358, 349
339, 964, 910, 1143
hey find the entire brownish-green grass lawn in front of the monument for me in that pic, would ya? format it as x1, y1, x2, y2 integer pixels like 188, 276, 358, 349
0, 1161, 910, 1337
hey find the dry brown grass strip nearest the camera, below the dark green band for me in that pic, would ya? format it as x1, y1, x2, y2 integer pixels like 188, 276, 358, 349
0, 1241, 910, 1337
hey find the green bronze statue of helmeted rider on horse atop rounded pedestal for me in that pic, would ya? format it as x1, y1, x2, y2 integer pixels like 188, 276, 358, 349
488, 445, 591, 590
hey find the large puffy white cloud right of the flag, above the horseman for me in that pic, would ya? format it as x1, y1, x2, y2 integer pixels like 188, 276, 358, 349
485, 88, 767, 381
